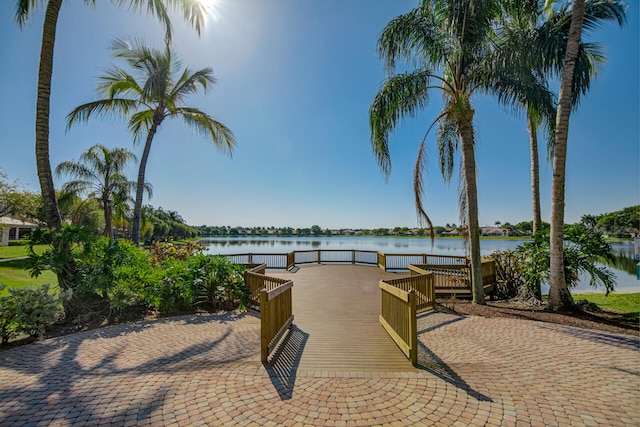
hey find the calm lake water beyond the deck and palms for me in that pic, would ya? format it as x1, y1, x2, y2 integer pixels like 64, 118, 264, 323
202, 236, 640, 292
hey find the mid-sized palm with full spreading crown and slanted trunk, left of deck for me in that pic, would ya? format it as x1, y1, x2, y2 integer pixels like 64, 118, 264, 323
67, 39, 235, 244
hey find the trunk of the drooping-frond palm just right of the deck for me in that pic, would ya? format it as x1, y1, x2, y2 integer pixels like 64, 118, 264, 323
458, 117, 486, 304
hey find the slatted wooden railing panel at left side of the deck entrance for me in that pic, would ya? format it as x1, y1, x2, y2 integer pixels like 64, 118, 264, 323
260, 278, 293, 362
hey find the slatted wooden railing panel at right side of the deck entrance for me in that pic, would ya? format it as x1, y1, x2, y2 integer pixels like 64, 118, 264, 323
379, 280, 418, 365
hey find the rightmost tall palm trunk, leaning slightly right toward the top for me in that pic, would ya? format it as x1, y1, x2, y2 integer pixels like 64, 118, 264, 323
549, 0, 584, 310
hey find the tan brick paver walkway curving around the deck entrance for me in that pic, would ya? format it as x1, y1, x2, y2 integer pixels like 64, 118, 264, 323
0, 266, 640, 426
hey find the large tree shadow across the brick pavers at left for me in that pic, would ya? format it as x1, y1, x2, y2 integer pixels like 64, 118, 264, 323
0, 316, 259, 425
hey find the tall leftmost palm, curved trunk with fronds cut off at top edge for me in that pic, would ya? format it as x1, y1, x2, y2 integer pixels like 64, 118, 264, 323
16, 0, 205, 300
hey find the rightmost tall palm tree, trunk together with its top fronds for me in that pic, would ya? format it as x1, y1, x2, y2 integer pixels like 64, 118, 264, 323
535, 0, 627, 310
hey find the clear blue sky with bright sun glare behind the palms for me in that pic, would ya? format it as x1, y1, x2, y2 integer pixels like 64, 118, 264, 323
0, 0, 640, 228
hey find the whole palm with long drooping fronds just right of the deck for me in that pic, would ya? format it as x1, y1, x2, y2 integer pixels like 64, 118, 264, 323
369, 0, 550, 304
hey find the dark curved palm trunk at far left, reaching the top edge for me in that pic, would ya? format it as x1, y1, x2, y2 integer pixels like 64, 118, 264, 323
35, 0, 62, 234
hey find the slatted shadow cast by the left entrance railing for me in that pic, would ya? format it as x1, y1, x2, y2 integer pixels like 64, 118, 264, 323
263, 325, 309, 400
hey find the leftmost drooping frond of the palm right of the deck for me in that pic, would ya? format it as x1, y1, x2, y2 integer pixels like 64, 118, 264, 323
369, 69, 432, 177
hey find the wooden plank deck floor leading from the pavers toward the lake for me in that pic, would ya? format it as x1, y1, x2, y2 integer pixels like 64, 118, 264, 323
267, 265, 415, 372
